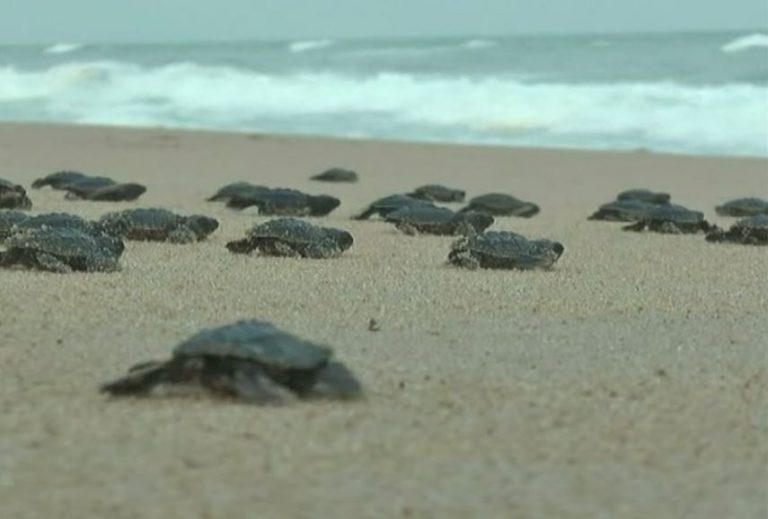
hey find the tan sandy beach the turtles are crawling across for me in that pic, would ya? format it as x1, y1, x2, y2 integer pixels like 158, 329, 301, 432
0, 124, 768, 519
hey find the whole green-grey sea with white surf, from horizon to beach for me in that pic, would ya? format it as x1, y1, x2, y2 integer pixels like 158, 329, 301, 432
0, 32, 768, 156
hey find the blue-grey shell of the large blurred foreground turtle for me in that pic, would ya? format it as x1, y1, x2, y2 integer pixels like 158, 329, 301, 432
173, 320, 332, 371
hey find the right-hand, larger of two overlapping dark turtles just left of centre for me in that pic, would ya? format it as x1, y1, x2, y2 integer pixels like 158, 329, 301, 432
227, 188, 341, 216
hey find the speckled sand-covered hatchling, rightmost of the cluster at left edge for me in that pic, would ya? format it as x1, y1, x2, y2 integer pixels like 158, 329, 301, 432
98, 208, 219, 243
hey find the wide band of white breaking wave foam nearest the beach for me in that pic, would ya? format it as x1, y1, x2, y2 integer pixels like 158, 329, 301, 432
0, 61, 768, 155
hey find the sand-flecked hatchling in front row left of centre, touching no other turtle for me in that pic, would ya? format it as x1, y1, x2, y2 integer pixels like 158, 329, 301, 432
227, 218, 354, 258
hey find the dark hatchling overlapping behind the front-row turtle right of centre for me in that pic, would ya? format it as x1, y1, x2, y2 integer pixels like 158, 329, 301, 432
384, 205, 493, 236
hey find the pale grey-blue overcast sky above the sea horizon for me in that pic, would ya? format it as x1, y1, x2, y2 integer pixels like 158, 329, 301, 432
0, 0, 768, 43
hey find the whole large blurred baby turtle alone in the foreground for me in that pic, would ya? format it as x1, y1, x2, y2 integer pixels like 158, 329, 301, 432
100, 320, 362, 404
